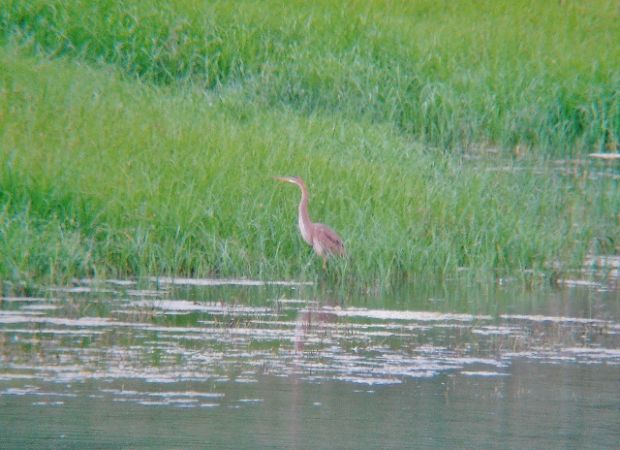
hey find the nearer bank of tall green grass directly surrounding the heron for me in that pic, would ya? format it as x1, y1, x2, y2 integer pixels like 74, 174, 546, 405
0, 45, 620, 282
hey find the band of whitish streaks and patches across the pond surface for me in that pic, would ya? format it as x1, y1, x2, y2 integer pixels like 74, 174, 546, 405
0, 284, 620, 408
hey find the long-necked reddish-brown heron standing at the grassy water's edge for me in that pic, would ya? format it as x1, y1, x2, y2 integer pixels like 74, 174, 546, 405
274, 177, 345, 270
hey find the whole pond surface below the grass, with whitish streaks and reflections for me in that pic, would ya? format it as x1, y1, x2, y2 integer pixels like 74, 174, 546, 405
0, 279, 620, 449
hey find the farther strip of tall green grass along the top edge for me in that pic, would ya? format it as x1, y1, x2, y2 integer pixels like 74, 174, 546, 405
0, 0, 620, 155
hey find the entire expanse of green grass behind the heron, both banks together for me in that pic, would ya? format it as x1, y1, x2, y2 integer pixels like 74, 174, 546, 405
0, 1, 620, 283
